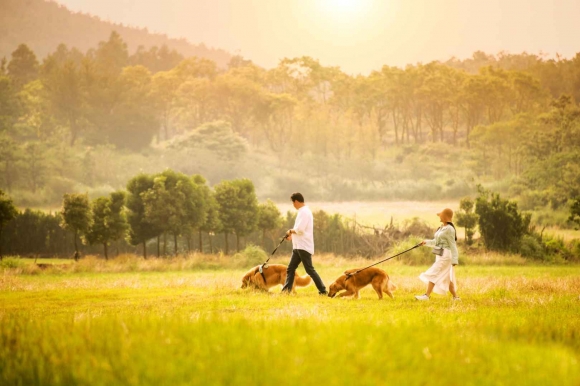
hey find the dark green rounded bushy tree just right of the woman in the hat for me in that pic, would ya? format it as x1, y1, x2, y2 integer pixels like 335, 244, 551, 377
475, 186, 530, 252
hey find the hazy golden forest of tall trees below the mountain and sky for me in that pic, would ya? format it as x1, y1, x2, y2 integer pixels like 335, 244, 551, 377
0, 32, 580, 213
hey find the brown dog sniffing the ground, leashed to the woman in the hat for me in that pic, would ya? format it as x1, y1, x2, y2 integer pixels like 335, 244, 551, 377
328, 267, 397, 299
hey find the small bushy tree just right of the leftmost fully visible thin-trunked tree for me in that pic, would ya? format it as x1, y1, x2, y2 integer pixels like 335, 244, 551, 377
85, 192, 127, 260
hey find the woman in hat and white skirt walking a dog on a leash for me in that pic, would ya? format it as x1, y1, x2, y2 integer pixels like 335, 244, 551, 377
415, 208, 459, 300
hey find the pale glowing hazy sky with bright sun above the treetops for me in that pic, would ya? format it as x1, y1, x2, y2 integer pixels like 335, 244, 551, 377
57, 0, 580, 74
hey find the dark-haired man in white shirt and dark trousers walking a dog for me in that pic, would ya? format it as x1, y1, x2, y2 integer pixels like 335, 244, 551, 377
282, 193, 327, 295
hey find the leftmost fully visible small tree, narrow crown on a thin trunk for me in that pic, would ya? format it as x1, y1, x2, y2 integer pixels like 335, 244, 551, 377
60, 194, 92, 261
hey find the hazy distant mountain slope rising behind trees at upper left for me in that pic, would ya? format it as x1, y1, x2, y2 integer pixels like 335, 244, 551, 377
0, 0, 231, 67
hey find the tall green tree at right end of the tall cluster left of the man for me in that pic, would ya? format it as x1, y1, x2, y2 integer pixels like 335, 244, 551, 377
215, 178, 258, 254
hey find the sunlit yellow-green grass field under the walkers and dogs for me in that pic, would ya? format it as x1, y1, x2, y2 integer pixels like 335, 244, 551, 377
0, 253, 580, 385
